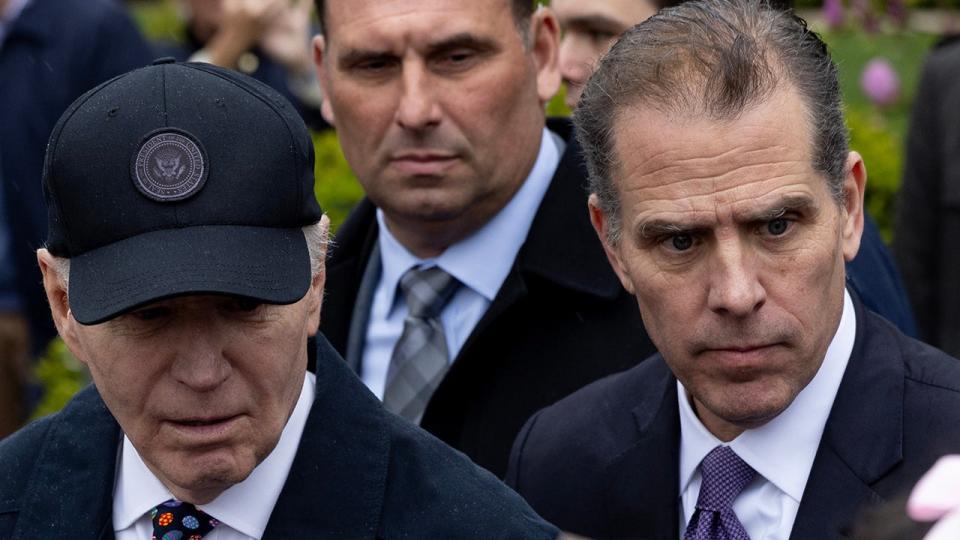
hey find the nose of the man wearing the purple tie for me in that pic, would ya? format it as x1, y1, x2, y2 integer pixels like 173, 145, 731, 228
707, 238, 767, 318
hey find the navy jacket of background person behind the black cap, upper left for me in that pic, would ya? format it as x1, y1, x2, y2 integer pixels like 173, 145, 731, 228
0, 0, 152, 352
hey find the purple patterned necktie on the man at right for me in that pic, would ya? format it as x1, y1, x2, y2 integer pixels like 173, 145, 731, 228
683, 446, 757, 540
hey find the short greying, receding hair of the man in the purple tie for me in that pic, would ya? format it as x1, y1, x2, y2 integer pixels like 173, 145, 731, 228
574, 0, 849, 245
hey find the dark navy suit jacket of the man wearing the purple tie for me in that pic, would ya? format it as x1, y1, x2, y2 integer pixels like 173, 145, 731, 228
507, 294, 960, 540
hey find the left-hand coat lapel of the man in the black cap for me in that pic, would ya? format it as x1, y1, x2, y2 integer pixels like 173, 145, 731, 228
13, 386, 120, 539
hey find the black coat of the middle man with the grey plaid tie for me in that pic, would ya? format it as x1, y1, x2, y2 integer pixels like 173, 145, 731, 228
320, 118, 654, 476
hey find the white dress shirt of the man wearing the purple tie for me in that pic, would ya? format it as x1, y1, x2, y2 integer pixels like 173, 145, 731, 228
677, 291, 857, 540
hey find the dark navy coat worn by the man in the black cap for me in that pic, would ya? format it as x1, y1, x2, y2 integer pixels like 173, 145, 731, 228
0, 339, 557, 540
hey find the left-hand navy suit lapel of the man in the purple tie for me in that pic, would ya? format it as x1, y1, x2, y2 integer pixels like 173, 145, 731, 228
605, 355, 680, 540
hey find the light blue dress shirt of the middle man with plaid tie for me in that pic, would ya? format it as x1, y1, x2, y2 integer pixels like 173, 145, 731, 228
360, 128, 560, 399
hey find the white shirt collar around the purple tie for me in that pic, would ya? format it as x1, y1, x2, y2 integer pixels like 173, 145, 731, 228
677, 290, 857, 503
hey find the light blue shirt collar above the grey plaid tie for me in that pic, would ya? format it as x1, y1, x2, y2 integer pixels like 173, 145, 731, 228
377, 128, 560, 307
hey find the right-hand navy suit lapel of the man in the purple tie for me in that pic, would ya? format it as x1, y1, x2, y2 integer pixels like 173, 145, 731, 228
791, 293, 904, 540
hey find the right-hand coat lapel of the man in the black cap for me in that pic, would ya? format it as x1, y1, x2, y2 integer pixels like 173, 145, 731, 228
264, 336, 390, 539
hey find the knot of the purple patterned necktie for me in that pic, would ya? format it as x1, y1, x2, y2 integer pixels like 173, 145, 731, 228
697, 446, 756, 512
